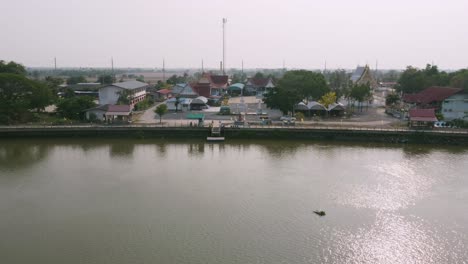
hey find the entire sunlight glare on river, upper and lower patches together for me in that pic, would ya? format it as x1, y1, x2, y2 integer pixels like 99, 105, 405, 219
322, 154, 468, 263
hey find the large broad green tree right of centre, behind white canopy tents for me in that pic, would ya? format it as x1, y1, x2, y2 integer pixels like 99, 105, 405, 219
263, 70, 330, 114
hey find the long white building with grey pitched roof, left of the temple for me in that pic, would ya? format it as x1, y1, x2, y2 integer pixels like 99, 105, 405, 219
99, 81, 148, 108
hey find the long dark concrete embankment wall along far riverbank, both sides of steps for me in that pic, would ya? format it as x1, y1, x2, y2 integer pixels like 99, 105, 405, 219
0, 126, 468, 146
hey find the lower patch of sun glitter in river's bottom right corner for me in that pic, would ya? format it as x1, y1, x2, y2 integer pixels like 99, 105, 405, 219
322, 212, 468, 263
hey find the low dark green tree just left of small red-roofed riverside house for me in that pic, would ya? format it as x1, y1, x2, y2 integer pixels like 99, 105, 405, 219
57, 96, 96, 120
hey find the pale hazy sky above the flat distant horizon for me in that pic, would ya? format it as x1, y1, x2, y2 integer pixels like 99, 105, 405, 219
0, 0, 468, 69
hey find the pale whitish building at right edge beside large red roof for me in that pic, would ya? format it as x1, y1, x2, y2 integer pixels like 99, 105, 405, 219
441, 93, 468, 121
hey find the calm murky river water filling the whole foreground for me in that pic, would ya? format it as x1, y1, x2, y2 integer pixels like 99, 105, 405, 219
0, 139, 468, 264
